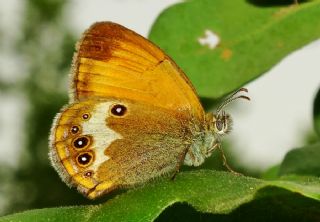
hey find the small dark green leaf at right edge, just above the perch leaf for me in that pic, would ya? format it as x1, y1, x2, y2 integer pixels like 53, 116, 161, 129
279, 143, 320, 177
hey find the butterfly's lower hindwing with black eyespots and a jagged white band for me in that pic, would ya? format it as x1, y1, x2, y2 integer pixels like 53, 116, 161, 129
50, 99, 191, 198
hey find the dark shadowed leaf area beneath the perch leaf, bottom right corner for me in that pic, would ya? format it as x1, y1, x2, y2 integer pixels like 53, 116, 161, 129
156, 187, 320, 222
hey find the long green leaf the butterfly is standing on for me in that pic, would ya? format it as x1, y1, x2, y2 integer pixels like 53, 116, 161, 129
0, 170, 320, 222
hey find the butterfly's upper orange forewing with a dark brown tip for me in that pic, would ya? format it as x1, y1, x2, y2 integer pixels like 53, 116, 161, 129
71, 22, 204, 119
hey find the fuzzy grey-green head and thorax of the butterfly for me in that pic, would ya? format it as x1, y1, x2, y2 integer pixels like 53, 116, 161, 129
184, 112, 232, 166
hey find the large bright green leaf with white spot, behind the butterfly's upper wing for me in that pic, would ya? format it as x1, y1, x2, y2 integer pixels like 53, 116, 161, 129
149, 0, 320, 99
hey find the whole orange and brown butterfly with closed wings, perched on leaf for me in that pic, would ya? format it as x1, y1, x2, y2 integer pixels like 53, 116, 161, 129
49, 22, 249, 199
